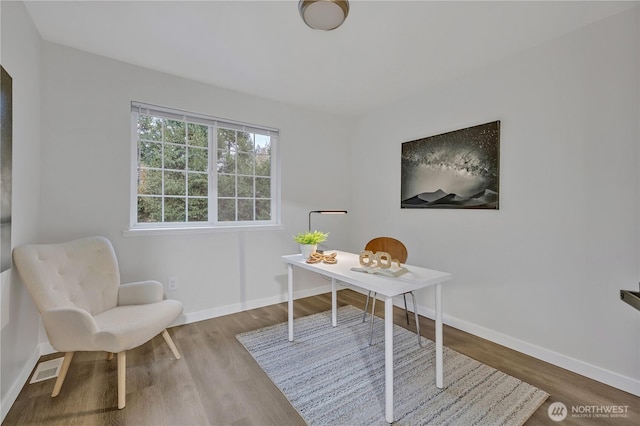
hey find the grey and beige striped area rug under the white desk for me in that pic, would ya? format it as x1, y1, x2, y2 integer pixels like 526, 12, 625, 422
236, 306, 549, 426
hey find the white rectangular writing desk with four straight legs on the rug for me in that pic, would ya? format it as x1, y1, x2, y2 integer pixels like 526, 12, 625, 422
282, 250, 451, 423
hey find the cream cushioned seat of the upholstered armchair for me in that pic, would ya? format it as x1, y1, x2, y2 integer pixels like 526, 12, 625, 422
92, 300, 182, 353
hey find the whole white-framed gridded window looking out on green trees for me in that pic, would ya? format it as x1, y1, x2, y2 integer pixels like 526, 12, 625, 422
131, 102, 279, 229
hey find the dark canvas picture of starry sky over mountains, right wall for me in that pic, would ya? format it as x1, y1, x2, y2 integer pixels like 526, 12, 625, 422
400, 121, 500, 210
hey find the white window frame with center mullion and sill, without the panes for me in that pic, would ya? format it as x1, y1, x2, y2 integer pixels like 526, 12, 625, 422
123, 101, 283, 236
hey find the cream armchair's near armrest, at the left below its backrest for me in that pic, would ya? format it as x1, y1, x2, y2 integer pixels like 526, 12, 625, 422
42, 308, 98, 352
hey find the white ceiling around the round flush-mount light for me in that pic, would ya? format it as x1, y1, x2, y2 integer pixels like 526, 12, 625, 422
25, 0, 638, 116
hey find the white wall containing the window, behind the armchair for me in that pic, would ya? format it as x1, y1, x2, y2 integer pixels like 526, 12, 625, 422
40, 43, 350, 321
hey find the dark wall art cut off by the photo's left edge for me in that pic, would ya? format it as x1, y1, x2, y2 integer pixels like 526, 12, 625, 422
0, 66, 13, 272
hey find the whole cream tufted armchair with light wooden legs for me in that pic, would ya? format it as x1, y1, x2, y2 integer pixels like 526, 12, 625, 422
13, 237, 183, 409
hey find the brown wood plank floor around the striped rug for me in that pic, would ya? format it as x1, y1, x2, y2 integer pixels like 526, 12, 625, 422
3, 290, 640, 426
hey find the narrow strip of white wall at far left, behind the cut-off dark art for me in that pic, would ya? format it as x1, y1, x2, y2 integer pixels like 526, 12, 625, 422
0, 1, 41, 418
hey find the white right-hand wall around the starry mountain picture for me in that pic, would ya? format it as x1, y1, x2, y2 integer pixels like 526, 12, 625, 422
350, 7, 640, 395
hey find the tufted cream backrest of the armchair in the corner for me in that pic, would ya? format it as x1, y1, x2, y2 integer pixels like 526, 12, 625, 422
13, 237, 120, 315
